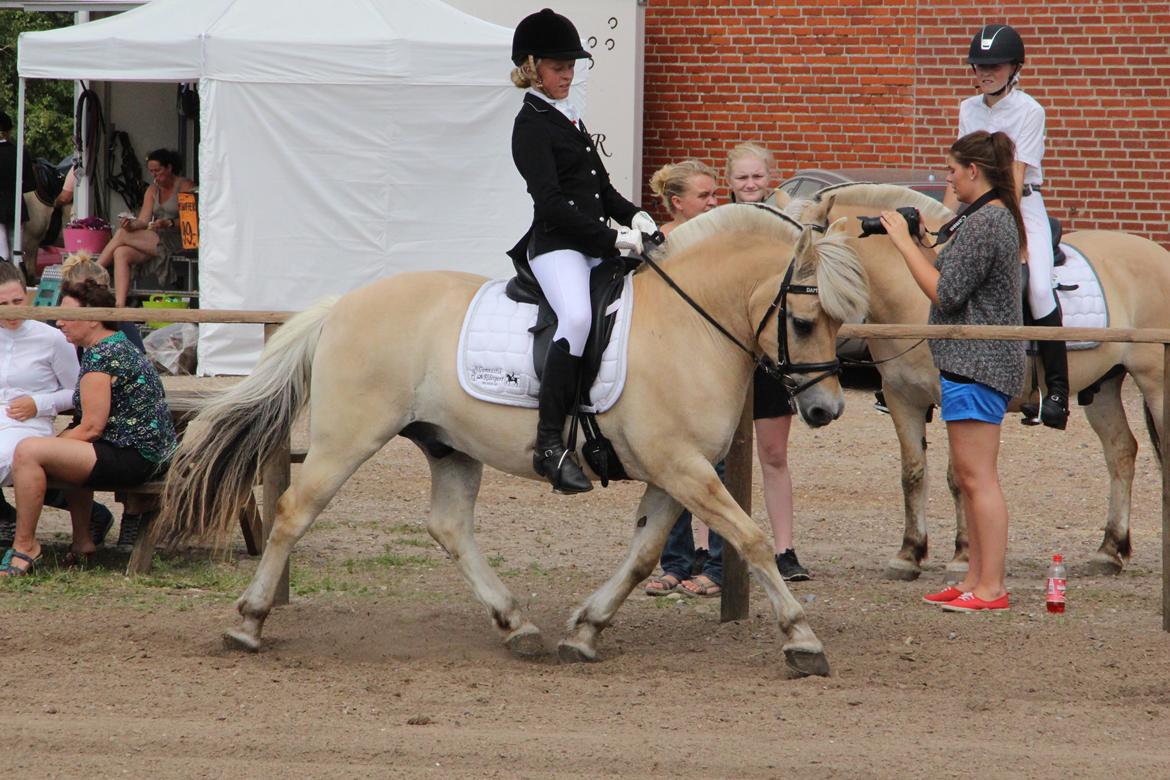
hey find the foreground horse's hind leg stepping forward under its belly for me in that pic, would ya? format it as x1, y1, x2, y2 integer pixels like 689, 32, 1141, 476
424, 450, 545, 657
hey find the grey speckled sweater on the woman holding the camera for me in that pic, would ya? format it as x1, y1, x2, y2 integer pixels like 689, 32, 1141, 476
929, 206, 1025, 396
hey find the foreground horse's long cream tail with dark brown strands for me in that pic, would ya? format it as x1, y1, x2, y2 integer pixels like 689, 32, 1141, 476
156, 297, 337, 550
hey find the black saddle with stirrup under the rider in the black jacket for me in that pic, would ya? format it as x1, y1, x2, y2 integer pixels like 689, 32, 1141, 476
504, 256, 641, 488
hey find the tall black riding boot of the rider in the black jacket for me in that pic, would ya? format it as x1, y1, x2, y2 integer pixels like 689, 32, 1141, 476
532, 339, 593, 493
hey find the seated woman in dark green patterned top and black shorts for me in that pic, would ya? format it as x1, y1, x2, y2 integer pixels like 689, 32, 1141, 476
0, 279, 176, 577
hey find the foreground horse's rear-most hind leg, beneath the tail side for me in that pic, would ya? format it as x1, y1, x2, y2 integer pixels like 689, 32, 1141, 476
223, 426, 392, 651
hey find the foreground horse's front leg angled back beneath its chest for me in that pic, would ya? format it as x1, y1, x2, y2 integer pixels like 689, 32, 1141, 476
557, 484, 682, 662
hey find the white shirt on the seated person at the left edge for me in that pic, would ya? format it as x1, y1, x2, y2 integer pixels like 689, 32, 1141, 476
0, 319, 81, 426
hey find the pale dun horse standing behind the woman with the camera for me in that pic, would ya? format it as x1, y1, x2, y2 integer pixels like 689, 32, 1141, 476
785, 184, 1170, 579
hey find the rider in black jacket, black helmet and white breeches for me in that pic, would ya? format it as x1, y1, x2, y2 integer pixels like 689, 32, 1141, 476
508, 8, 658, 493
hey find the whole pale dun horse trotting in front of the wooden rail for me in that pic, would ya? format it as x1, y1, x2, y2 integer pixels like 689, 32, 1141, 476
159, 206, 867, 675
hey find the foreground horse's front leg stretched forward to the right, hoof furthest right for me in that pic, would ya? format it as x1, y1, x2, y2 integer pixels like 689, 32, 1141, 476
665, 457, 828, 676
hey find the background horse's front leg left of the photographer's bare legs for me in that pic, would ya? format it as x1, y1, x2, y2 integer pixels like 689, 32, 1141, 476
883, 386, 929, 580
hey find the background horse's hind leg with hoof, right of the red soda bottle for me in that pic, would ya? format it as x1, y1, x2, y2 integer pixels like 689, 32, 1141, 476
1085, 377, 1137, 574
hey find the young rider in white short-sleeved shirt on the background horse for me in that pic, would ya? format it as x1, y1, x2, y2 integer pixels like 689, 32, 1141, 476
944, 25, 1068, 429
